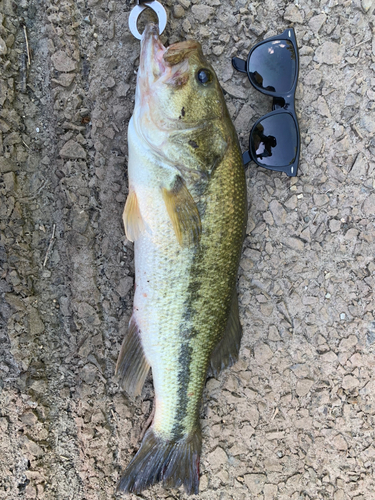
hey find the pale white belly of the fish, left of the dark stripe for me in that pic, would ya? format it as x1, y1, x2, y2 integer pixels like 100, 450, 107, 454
128, 116, 193, 427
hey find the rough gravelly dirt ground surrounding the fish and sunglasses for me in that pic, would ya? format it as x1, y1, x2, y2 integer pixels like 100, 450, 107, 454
0, 0, 375, 500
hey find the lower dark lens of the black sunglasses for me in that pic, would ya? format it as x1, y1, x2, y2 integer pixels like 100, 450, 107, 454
250, 113, 298, 168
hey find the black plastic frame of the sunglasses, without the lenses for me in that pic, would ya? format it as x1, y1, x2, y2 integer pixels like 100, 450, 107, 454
232, 28, 301, 177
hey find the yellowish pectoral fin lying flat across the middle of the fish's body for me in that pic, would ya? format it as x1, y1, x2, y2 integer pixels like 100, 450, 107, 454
163, 176, 202, 246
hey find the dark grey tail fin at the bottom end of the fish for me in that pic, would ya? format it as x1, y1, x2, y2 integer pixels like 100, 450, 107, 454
117, 427, 202, 495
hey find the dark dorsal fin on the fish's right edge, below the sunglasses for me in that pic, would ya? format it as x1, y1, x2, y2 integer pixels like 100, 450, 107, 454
210, 289, 242, 377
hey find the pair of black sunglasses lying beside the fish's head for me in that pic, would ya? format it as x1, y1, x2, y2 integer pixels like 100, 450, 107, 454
232, 28, 301, 176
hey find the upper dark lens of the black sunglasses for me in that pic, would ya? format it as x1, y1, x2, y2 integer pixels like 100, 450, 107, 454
248, 40, 296, 93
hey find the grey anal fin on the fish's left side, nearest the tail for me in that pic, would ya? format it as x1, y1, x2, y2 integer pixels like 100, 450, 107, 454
116, 316, 150, 396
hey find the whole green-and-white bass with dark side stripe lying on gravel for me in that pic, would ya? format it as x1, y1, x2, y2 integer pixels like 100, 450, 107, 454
116, 23, 247, 495
